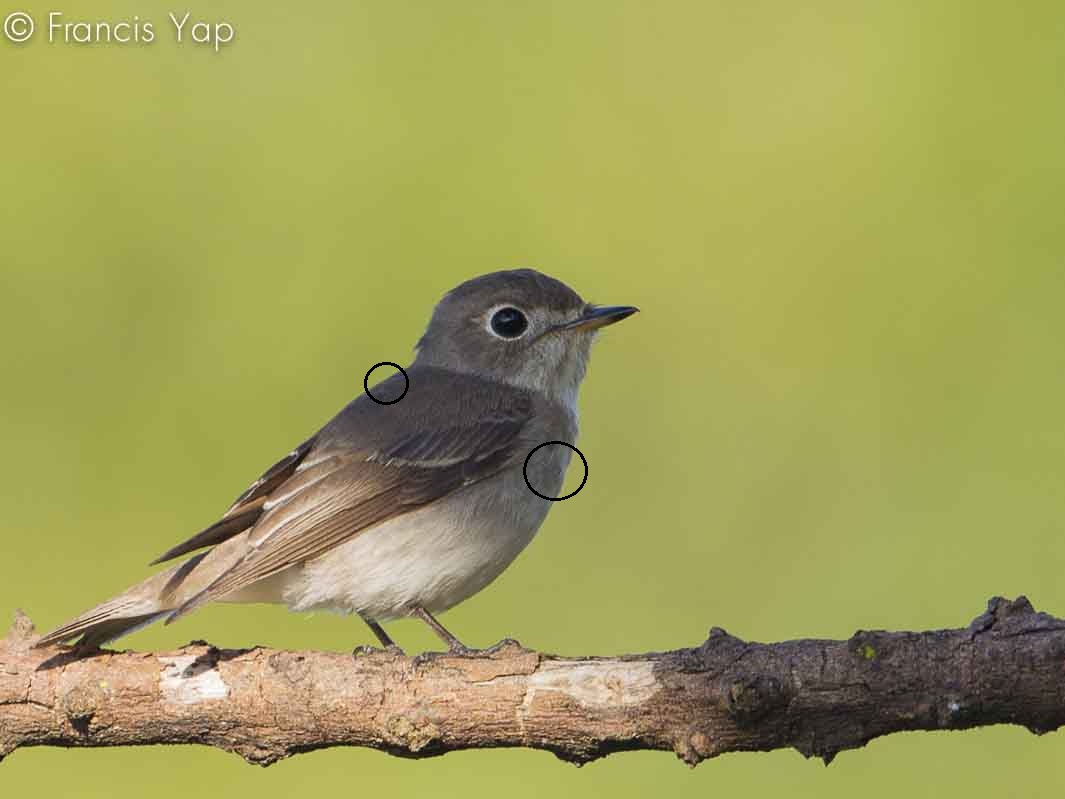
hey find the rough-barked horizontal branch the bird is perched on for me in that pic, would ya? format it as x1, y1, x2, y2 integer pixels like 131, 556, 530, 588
0, 597, 1065, 765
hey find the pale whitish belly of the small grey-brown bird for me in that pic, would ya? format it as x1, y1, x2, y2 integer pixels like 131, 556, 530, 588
283, 463, 564, 621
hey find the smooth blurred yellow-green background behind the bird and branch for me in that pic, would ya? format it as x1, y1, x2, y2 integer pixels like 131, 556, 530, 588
0, 0, 1065, 799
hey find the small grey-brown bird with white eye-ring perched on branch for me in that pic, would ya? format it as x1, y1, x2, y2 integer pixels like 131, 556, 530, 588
35, 268, 638, 654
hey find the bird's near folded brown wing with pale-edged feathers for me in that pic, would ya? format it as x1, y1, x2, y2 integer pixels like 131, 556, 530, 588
167, 403, 530, 623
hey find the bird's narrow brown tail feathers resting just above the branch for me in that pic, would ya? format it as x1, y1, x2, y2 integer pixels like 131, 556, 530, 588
33, 552, 208, 648
